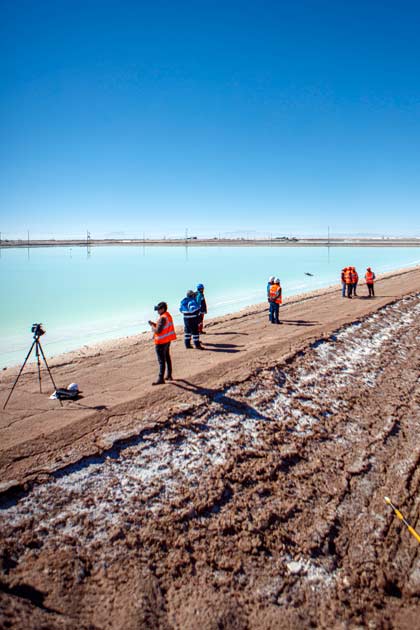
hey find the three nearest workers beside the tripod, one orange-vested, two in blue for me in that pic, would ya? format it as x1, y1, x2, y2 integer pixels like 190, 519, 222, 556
149, 284, 207, 385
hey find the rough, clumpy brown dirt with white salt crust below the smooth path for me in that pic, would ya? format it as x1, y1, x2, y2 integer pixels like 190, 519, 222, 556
0, 294, 420, 628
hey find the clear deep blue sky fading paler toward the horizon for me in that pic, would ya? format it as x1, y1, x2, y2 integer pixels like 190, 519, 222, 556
0, 0, 420, 238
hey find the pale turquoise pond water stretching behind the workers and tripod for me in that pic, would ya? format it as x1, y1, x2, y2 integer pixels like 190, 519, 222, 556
0, 246, 420, 367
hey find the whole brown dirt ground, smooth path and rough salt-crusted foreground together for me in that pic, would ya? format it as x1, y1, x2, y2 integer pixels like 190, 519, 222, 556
0, 269, 420, 629
